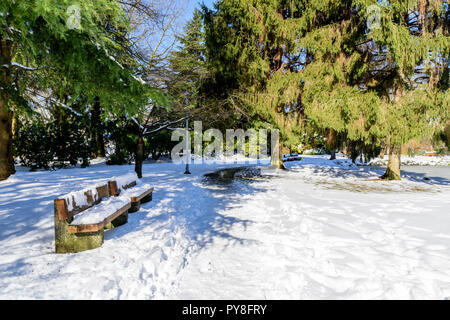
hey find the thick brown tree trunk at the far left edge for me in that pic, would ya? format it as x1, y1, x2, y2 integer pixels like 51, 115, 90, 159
0, 37, 16, 181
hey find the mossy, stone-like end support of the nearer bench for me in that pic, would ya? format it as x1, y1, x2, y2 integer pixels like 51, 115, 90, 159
55, 217, 104, 253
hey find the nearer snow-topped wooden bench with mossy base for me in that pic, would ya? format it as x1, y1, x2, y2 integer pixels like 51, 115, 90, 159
54, 184, 131, 253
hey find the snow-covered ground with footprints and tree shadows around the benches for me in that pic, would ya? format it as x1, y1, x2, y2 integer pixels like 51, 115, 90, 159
0, 156, 450, 299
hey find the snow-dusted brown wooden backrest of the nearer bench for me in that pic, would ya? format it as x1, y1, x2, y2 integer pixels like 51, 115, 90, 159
55, 184, 111, 221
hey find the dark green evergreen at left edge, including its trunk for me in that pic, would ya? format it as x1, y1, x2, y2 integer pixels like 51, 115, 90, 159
0, 0, 151, 180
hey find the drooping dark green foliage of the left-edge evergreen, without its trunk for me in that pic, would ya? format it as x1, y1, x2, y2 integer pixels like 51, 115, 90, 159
0, 0, 139, 108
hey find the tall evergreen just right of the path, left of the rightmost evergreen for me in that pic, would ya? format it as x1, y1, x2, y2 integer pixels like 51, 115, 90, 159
203, 0, 303, 168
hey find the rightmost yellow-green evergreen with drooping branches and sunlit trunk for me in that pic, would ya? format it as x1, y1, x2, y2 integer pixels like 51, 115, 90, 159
299, 1, 450, 179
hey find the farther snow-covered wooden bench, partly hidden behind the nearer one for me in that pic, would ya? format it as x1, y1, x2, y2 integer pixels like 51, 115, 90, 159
108, 180, 155, 213
